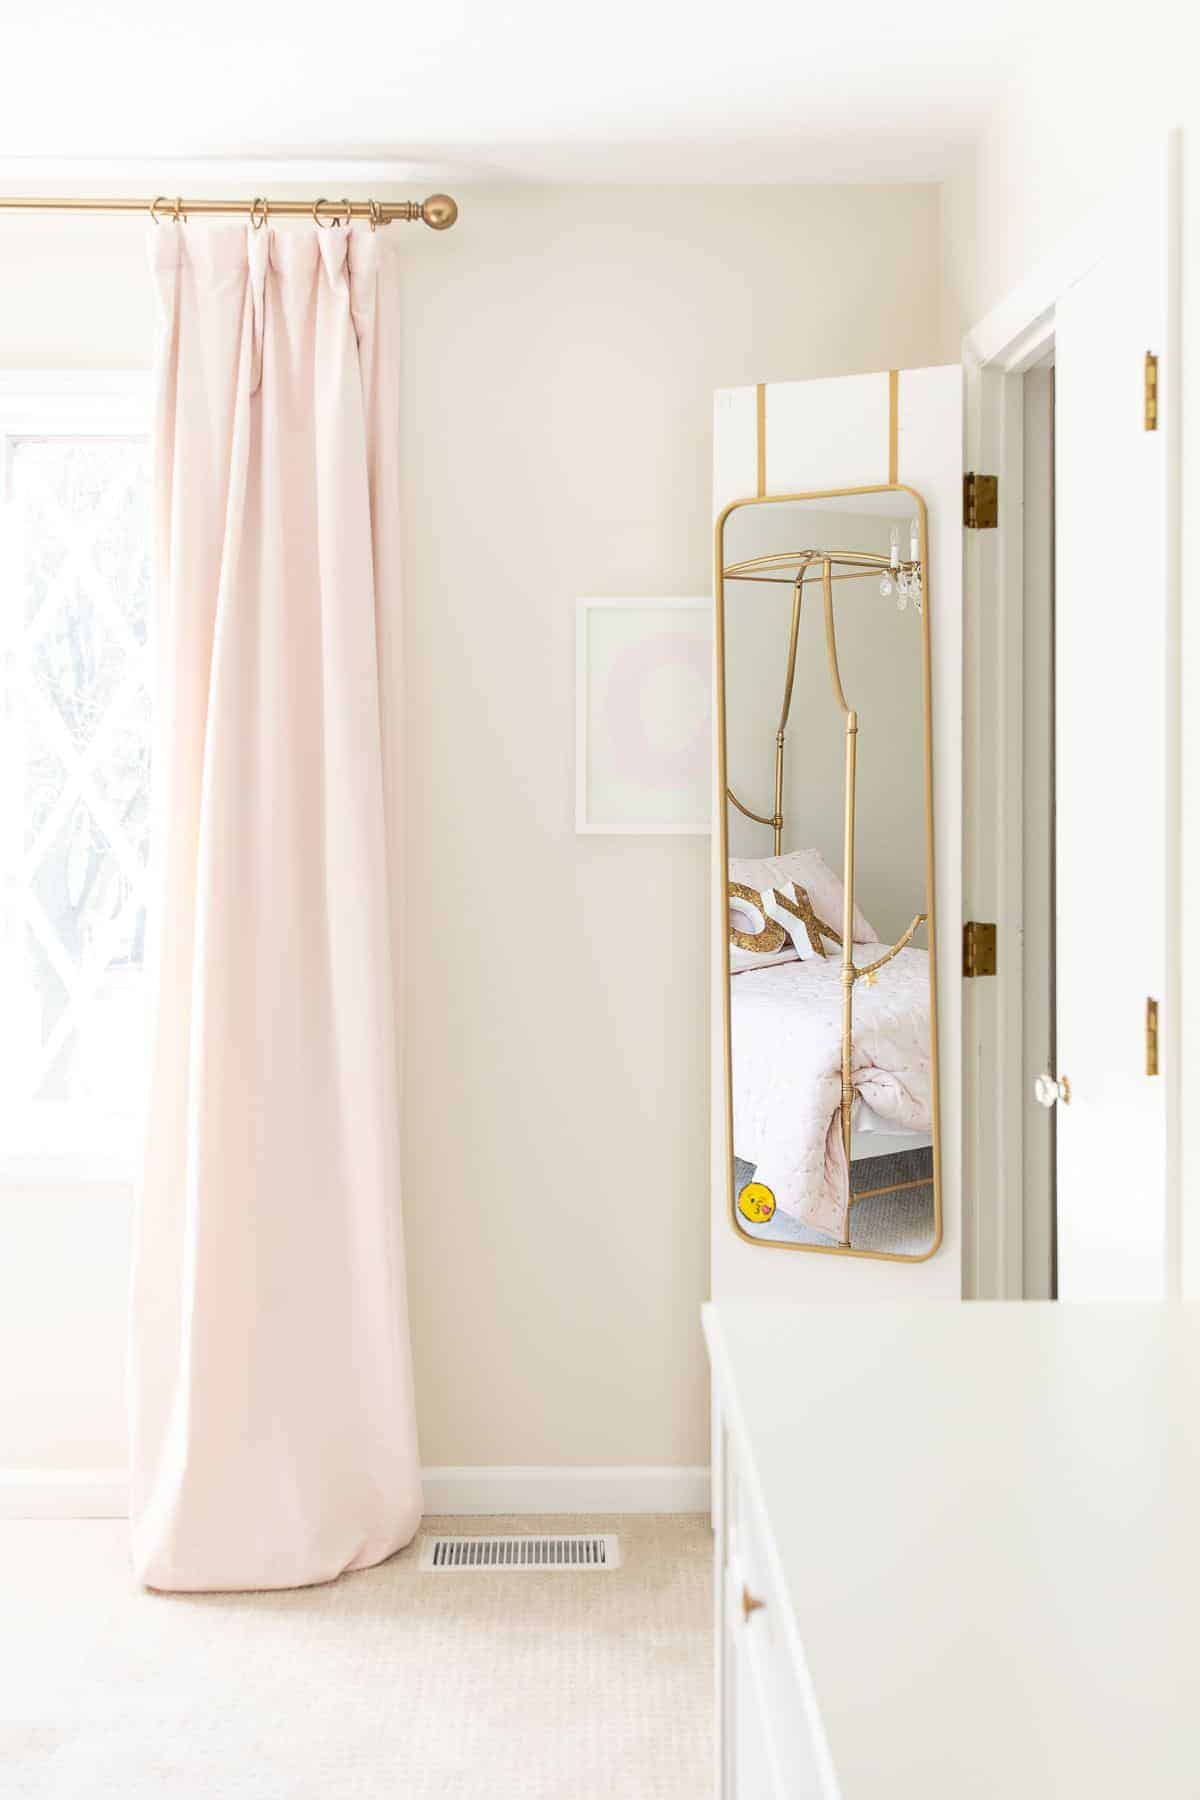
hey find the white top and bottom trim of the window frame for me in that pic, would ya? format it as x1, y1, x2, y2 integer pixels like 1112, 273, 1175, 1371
0, 369, 151, 1188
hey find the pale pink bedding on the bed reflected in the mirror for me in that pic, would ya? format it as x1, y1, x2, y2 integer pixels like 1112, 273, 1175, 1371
730, 943, 932, 1238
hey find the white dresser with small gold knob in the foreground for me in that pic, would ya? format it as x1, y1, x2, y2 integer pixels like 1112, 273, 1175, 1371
703, 1301, 1200, 1800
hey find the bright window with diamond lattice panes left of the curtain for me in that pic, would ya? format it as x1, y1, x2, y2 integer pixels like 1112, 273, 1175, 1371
0, 376, 151, 1172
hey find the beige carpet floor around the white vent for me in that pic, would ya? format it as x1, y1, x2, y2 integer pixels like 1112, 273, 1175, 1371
0, 1517, 712, 1800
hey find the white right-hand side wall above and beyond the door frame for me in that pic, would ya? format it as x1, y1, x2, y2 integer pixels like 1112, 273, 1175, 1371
943, 14, 1200, 1296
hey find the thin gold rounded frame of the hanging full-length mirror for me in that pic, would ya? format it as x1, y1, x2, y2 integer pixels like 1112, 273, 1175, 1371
714, 481, 943, 1262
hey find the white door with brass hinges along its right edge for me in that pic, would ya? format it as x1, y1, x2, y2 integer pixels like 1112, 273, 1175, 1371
1054, 175, 1171, 1300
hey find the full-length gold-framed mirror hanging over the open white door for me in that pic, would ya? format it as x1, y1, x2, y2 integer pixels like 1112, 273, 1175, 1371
716, 486, 941, 1262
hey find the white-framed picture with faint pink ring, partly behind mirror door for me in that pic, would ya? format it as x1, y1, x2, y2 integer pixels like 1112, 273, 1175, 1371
576, 594, 712, 837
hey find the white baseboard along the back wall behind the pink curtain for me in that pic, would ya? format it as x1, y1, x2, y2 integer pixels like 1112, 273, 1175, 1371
0, 1463, 709, 1519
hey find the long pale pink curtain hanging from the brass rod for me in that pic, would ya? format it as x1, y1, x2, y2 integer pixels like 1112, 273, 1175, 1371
130, 223, 421, 1589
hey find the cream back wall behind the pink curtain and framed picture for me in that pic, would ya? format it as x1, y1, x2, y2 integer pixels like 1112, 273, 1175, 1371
0, 187, 941, 1490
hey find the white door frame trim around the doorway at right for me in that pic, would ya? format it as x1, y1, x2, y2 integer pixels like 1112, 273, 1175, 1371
963, 131, 1180, 1300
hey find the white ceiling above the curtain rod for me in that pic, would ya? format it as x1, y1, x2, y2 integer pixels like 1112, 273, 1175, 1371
0, 0, 1013, 189
